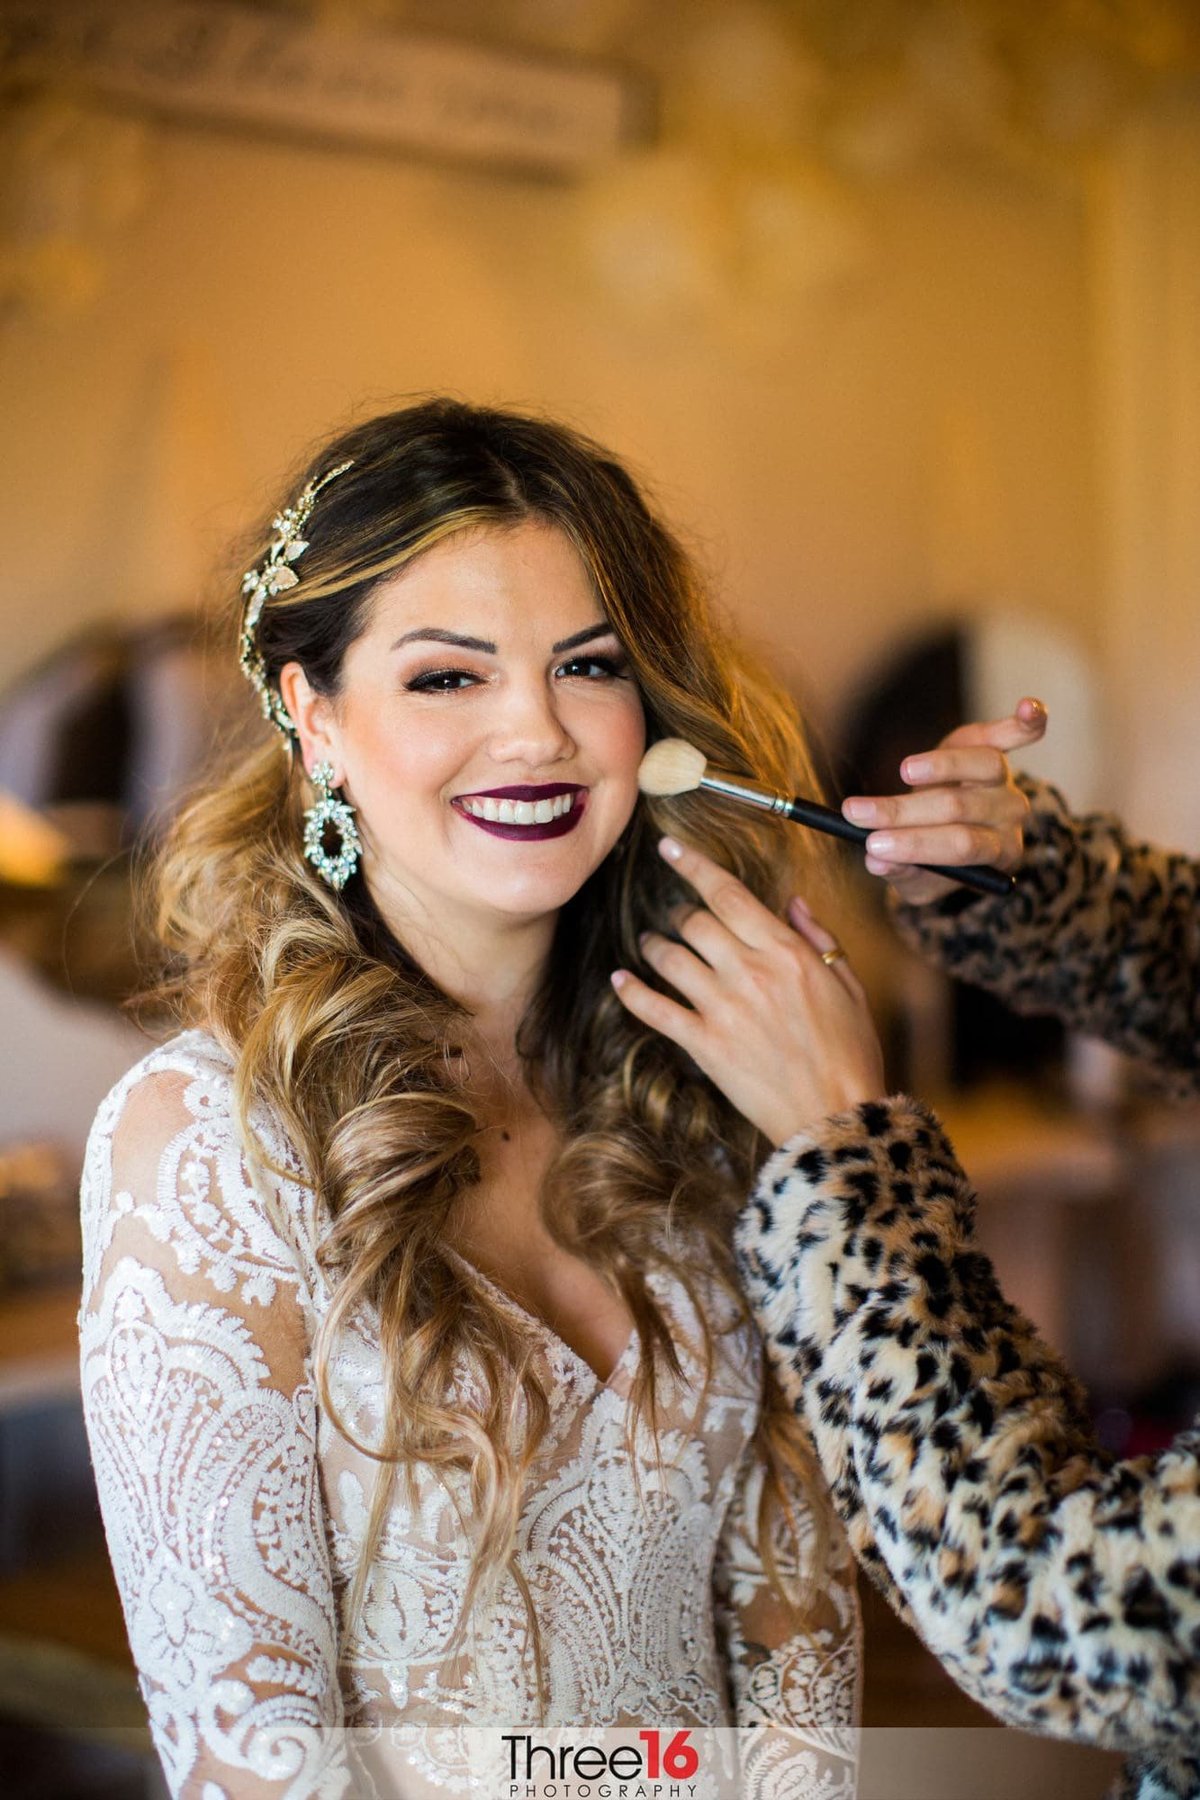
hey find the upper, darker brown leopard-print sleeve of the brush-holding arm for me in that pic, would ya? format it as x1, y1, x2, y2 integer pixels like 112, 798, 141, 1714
894, 776, 1200, 1093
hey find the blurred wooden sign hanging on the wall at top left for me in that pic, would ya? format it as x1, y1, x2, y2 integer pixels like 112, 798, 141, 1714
0, 0, 649, 176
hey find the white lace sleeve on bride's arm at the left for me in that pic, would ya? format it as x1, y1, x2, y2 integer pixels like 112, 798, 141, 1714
79, 1053, 349, 1800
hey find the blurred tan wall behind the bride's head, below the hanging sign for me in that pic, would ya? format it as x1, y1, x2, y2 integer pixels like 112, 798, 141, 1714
0, 63, 1200, 830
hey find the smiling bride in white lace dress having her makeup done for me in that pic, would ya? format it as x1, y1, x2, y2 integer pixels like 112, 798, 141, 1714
81, 400, 858, 1800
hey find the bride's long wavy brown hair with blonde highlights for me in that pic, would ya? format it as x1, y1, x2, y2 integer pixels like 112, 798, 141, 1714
155, 400, 841, 1661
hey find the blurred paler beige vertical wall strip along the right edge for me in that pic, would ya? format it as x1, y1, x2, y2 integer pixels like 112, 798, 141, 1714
1090, 92, 1200, 846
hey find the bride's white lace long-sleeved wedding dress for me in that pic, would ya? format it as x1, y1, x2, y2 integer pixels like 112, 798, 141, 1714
79, 1031, 860, 1800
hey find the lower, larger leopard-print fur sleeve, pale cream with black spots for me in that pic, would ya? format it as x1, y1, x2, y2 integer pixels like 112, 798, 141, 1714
738, 1096, 1200, 1796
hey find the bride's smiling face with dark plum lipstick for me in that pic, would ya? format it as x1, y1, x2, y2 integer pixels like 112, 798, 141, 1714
282, 520, 646, 934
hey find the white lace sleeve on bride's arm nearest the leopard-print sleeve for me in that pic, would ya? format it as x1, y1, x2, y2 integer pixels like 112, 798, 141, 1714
714, 1447, 862, 1800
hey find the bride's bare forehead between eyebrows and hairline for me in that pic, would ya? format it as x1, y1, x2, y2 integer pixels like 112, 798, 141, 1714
361, 518, 604, 637
